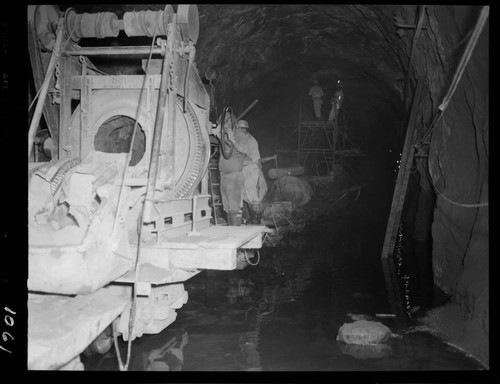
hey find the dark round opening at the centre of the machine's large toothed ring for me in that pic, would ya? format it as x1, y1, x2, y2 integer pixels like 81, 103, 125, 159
94, 116, 146, 167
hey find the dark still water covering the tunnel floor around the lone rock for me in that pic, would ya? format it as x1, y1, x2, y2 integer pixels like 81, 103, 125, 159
84, 189, 482, 371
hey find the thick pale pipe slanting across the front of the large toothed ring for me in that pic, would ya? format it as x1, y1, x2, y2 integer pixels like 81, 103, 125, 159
143, 40, 170, 222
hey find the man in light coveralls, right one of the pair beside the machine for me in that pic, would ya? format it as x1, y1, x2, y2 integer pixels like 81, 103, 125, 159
238, 120, 267, 224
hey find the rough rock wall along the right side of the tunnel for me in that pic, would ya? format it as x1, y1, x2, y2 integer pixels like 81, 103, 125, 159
394, 6, 489, 365
